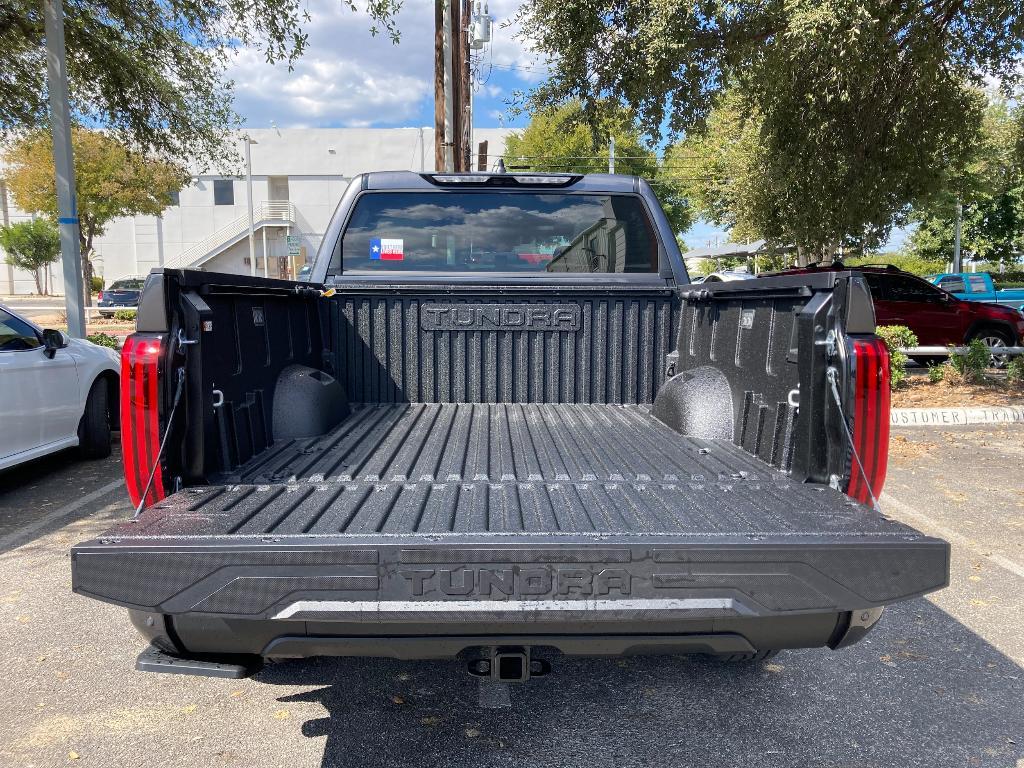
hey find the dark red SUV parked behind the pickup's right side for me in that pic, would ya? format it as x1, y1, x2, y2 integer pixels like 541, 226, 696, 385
787, 264, 1024, 361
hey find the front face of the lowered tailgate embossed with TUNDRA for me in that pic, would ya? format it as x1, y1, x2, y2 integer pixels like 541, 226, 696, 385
72, 534, 949, 634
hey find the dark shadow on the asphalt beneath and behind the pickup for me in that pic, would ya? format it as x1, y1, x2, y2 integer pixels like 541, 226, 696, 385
258, 600, 1024, 768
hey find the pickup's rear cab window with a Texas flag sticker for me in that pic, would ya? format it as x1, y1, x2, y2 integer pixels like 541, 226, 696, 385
332, 191, 657, 273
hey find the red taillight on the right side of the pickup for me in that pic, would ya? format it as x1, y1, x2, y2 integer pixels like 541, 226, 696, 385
846, 339, 889, 504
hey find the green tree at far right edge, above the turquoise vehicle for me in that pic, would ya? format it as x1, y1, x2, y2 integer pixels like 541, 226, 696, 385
908, 98, 1024, 268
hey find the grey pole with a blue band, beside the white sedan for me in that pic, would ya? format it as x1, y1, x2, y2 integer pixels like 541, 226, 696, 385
43, 0, 86, 339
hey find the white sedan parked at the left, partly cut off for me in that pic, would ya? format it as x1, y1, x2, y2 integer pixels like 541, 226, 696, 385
0, 306, 120, 469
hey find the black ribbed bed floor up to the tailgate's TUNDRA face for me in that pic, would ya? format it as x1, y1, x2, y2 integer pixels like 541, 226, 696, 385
125, 403, 906, 536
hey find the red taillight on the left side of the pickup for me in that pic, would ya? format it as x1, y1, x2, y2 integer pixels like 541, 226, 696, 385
121, 334, 167, 507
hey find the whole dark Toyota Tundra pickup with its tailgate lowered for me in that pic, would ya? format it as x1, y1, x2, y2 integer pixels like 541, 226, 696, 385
72, 172, 949, 680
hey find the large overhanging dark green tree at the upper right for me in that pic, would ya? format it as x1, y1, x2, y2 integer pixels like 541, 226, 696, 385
521, 0, 1011, 260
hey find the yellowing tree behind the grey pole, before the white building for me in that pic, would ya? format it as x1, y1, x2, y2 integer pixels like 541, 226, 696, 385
3, 128, 188, 305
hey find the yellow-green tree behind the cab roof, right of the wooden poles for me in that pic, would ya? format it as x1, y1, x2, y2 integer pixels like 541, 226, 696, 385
505, 100, 693, 233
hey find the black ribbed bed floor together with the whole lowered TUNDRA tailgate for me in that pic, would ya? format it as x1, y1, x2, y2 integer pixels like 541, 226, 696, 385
73, 403, 949, 631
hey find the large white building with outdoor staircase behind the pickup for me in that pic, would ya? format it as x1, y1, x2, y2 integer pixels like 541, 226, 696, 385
0, 128, 510, 296
